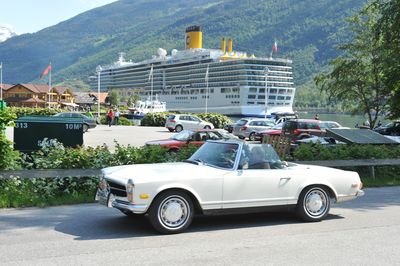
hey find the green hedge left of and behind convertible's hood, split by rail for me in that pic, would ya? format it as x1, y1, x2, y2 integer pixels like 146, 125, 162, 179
0, 140, 197, 208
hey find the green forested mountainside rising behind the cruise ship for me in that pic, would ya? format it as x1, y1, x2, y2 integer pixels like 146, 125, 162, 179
0, 0, 366, 90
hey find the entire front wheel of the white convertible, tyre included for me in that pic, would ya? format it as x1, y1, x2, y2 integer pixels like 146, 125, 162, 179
149, 191, 194, 234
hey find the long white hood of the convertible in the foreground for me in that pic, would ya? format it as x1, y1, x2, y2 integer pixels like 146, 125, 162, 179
102, 162, 222, 184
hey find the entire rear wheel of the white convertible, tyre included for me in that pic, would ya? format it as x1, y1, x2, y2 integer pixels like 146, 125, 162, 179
296, 186, 330, 222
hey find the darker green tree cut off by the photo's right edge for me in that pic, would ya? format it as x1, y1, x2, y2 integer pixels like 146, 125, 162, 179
374, 0, 400, 118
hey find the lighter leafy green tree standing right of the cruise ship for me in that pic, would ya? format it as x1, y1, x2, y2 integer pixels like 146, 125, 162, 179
314, 4, 390, 127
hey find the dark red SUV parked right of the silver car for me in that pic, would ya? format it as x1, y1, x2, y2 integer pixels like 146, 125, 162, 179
282, 119, 325, 141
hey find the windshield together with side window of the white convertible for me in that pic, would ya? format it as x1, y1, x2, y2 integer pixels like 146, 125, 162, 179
189, 142, 282, 169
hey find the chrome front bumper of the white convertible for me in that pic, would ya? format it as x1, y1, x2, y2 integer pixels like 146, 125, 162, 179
95, 189, 148, 214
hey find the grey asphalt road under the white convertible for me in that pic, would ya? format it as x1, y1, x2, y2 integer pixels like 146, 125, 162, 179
0, 187, 400, 265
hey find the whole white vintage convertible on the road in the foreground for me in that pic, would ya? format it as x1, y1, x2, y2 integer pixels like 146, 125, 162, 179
96, 140, 364, 233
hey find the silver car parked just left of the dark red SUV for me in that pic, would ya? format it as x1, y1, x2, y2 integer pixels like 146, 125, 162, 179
232, 118, 275, 141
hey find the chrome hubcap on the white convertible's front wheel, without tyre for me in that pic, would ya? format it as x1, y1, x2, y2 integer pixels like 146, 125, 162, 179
158, 196, 190, 229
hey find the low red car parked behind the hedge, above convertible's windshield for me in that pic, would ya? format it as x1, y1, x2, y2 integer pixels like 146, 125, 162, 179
146, 129, 230, 151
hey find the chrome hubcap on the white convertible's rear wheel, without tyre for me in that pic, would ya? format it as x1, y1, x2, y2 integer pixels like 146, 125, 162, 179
304, 189, 328, 217
